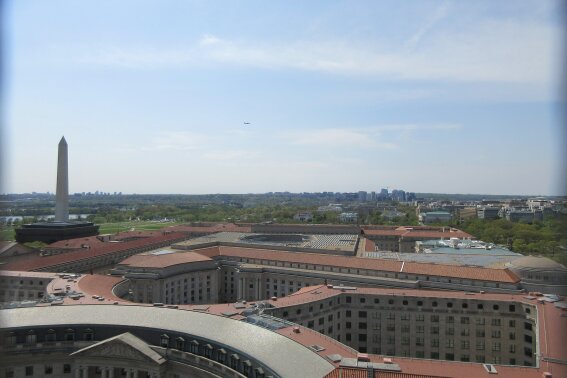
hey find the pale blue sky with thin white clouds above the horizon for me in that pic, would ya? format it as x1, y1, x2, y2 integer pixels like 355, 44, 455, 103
0, 0, 567, 195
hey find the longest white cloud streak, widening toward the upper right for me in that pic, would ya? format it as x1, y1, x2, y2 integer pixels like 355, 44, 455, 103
72, 14, 560, 90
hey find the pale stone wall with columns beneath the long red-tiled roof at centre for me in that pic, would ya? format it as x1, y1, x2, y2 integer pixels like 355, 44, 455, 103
121, 256, 520, 304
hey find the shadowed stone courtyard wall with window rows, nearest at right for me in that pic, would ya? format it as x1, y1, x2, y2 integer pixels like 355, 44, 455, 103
266, 293, 537, 366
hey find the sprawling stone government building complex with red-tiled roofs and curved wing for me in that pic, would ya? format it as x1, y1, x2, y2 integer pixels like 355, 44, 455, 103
0, 225, 567, 378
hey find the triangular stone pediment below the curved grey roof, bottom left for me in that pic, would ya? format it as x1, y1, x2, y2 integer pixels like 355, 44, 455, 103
71, 332, 165, 365
